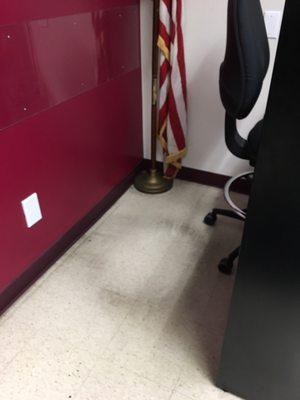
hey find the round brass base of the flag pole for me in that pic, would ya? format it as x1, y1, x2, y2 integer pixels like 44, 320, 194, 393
134, 169, 173, 194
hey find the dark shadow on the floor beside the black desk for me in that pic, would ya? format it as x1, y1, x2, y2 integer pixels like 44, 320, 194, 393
168, 194, 248, 383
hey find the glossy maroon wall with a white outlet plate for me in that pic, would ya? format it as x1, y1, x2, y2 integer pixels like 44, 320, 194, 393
0, 0, 142, 292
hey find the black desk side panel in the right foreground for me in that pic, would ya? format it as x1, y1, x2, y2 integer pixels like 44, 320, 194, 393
218, 0, 300, 400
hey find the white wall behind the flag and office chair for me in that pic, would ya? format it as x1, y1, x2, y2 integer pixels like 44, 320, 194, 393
141, 0, 285, 175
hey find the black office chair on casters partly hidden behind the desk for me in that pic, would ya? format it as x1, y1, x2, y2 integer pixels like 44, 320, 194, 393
204, 0, 270, 274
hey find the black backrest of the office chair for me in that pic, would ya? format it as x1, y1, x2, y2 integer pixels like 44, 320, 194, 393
220, 0, 270, 119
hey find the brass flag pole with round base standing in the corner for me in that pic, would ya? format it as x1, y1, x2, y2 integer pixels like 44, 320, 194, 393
134, 0, 173, 194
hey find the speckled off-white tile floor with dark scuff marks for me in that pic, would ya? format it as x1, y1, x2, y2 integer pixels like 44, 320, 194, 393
0, 181, 245, 400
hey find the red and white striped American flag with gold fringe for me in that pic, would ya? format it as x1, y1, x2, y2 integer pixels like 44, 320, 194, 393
158, 0, 187, 178
